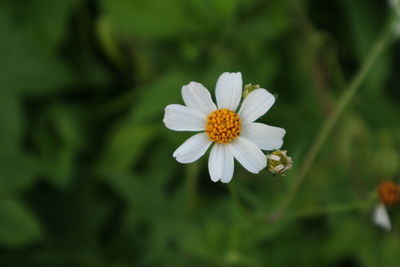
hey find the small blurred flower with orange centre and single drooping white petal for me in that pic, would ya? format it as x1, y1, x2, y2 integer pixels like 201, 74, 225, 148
372, 181, 400, 231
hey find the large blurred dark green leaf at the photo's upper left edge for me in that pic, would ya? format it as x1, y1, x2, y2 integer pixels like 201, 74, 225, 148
0, 4, 71, 94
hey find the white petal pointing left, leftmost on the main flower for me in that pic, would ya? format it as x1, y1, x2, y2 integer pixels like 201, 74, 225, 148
163, 104, 206, 131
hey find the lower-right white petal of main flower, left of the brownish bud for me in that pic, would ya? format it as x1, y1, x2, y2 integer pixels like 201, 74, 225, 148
228, 137, 267, 173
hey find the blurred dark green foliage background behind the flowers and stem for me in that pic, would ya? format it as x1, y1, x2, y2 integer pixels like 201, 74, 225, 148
0, 0, 400, 267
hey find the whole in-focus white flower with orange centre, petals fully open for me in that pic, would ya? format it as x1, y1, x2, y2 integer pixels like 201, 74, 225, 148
163, 72, 286, 183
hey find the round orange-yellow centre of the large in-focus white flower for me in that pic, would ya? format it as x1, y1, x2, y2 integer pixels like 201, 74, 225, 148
206, 108, 241, 144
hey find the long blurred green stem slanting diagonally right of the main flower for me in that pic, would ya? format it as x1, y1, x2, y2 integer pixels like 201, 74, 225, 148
270, 23, 392, 220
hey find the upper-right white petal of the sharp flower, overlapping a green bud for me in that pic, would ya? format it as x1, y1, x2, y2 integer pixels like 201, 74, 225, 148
239, 88, 275, 125
